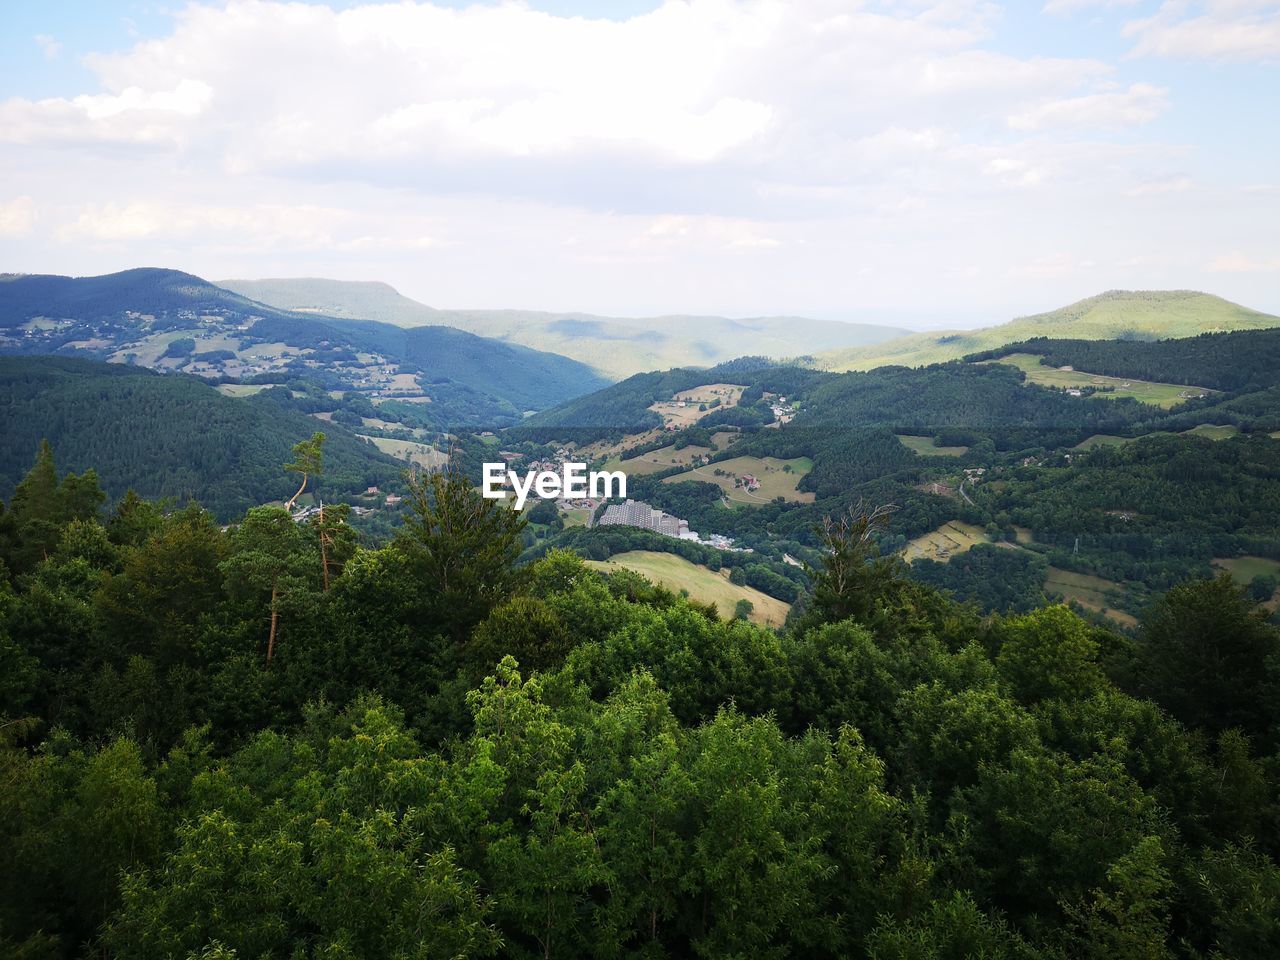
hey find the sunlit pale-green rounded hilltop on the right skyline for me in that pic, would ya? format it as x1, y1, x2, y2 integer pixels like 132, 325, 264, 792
815, 291, 1280, 370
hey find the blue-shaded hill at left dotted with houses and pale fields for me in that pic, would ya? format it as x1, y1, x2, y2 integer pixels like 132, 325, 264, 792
0, 268, 608, 417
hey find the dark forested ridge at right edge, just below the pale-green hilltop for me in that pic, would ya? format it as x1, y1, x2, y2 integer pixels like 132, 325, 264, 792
968, 326, 1280, 392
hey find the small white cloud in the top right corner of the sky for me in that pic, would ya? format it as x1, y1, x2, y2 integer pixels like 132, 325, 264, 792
1124, 0, 1280, 60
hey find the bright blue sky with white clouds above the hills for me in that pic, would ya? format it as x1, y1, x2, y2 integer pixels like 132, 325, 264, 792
0, 0, 1280, 329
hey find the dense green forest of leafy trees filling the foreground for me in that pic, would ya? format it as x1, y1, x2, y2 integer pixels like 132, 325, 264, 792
0, 448, 1280, 960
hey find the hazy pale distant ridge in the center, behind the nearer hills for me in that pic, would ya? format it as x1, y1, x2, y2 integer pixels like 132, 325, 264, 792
219, 279, 906, 380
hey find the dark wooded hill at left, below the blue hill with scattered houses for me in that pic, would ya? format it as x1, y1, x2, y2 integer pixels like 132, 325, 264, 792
0, 357, 403, 518
